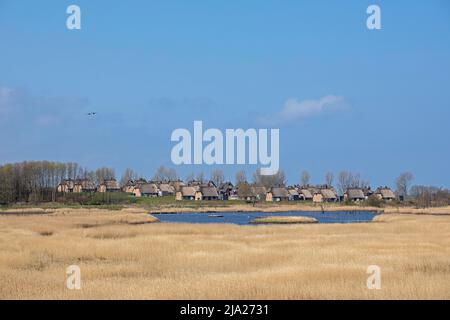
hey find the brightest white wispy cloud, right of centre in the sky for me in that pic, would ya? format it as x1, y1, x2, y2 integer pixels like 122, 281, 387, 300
260, 95, 348, 124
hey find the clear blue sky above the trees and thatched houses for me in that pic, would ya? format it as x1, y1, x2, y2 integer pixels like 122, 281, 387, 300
0, 0, 450, 187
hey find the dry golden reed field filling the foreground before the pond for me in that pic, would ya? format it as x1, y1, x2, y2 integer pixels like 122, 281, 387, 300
0, 209, 450, 299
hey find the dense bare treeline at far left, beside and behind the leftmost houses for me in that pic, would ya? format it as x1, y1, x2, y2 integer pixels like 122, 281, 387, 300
0, 161, 115, 204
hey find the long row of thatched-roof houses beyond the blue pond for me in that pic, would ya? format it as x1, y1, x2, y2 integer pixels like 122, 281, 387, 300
57, 179, 396, 203
